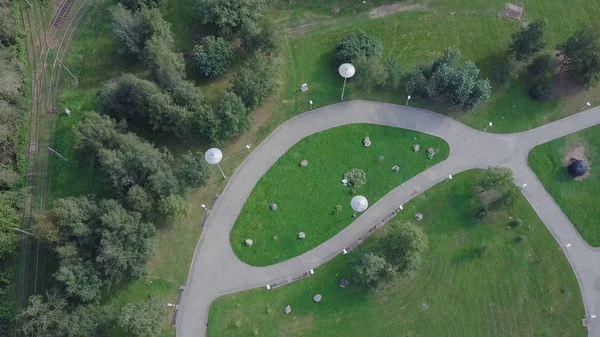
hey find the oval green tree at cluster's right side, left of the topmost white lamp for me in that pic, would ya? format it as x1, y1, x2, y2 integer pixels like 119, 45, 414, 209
233, 53, 275, 110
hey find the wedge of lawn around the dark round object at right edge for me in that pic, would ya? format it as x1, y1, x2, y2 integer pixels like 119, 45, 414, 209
529, 126, 600, 247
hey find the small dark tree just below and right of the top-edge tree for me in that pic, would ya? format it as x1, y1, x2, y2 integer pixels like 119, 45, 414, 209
241, 19, 280, 54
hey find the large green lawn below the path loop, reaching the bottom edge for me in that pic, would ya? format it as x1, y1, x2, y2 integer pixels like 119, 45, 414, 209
208, 171, 587, 337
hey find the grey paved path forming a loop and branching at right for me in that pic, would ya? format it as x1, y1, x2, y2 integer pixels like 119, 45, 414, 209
177, 101, 600, 337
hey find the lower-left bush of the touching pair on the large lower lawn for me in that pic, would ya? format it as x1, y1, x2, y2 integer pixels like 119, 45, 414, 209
352, 253, 396, 288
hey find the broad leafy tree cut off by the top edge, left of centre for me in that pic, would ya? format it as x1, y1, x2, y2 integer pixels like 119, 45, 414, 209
198, 0, 267, 35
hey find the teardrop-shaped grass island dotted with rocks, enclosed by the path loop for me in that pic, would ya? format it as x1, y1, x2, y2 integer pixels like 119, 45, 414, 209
230, 124, 449, 266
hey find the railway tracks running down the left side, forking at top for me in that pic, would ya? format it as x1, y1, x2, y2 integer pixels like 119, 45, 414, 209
15, 0, 92, 330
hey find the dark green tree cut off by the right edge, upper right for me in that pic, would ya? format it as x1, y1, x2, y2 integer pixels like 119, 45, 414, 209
556, 28, 600, 88
